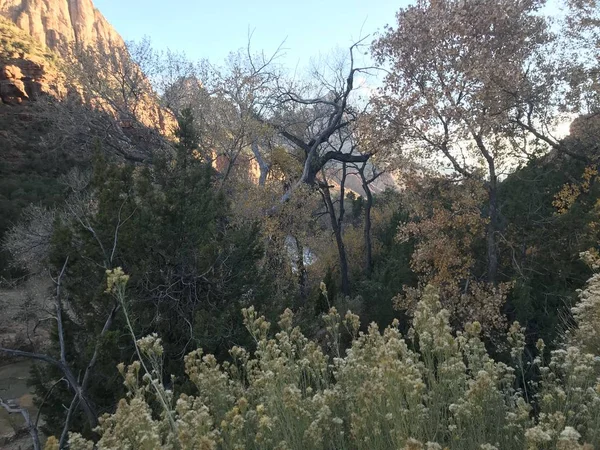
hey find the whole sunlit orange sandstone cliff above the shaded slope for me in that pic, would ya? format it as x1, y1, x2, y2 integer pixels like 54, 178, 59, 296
0, 0, 175, 135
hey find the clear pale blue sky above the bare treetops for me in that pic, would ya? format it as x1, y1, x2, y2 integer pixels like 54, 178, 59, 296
94, 0, 408, 68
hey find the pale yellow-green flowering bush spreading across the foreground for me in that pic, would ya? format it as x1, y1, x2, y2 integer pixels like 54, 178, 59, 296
47, 268, 600, 450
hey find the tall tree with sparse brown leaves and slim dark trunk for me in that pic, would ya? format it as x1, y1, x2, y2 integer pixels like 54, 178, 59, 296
373, 0, 547, 283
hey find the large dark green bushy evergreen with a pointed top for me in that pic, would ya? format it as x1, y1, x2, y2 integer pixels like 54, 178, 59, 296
32, 112, 268, 434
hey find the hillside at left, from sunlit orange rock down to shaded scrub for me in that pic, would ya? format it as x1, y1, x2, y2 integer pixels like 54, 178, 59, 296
0, 0, 173, 281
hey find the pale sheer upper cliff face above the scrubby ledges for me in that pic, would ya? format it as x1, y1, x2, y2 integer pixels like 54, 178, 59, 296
0, 0, 124, 54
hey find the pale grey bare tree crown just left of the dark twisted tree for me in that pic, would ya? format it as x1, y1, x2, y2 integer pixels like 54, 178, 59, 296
163, 35, 282, 186
